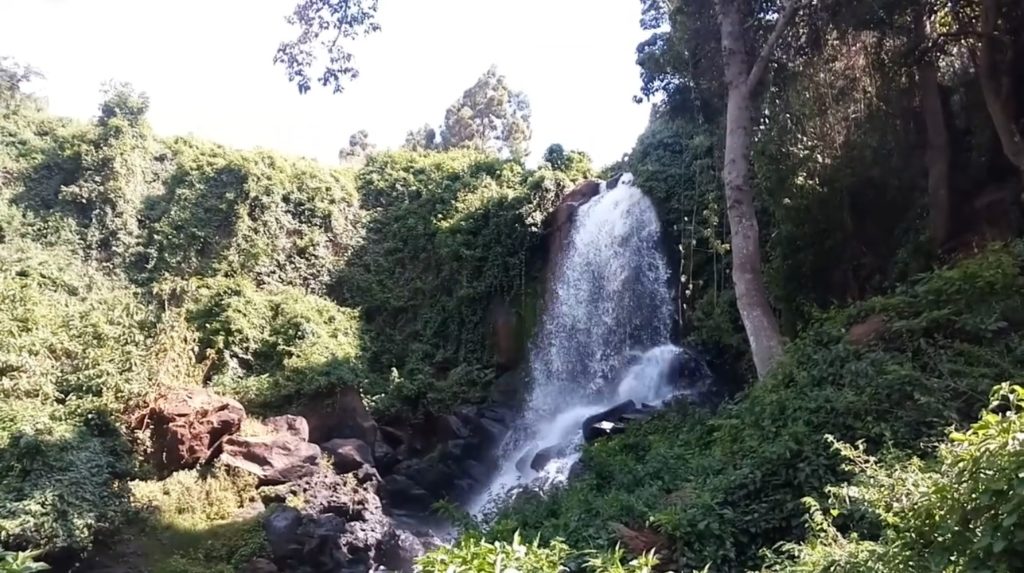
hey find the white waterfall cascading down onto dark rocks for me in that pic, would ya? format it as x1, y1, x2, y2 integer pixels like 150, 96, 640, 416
469, 173, 708, 517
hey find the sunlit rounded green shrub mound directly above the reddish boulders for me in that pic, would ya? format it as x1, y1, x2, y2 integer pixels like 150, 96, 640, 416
174, 278, 370, 411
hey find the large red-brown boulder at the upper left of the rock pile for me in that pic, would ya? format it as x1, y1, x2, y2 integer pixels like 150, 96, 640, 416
141, 388, 246, 473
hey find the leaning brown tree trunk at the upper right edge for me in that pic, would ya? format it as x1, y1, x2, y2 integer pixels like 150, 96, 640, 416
975, 0, 1024, 181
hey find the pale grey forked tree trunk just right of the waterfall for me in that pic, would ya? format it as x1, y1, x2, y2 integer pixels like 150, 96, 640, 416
718, 0, 797, 379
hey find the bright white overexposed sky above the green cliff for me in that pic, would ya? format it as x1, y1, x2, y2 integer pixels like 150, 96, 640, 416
0, 0, 649, 166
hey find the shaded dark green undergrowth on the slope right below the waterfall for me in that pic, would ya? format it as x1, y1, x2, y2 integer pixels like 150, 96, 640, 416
488, 245, 1024, 571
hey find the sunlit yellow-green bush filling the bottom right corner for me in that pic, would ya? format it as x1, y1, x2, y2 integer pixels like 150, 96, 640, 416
771, 384, 1024, 573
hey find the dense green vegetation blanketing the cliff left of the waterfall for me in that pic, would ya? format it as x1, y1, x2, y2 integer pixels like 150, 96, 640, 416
0, 69, 590, 570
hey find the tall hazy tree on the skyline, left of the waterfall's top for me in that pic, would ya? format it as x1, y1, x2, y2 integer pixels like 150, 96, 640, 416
440, 67, 530, 160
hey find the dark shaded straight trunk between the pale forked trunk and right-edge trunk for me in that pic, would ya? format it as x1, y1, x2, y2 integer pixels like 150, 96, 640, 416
914, 11, 950, 250
